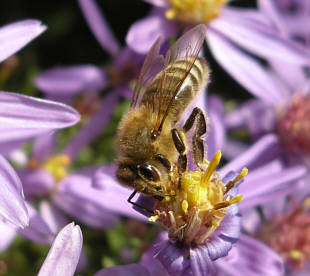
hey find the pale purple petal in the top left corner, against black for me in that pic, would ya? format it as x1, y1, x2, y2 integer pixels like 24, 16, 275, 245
0, 20, 46, 62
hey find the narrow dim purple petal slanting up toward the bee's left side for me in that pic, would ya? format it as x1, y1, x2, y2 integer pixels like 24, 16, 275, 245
63, 91, 118, 160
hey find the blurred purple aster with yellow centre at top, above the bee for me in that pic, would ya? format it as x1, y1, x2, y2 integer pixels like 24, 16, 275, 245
126, 0, 310, 96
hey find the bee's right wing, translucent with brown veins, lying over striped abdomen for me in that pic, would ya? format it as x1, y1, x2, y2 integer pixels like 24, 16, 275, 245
156, 24, 206, 132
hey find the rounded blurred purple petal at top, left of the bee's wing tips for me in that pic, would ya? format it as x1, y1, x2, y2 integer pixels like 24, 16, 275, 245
126, 11, 177, 54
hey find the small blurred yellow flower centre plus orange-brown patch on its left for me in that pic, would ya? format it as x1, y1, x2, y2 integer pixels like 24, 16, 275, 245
28, 154, 71, 182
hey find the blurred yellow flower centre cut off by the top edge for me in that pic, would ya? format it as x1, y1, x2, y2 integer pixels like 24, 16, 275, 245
166, 0, 227, 24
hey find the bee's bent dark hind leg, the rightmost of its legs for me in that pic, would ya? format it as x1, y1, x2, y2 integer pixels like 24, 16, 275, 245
183, 107, 207, 169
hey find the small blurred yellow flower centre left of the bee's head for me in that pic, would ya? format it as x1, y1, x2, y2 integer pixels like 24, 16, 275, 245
41, 155, 70, 182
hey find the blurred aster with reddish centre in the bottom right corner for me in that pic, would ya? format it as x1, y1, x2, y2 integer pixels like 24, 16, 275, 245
243, 194, 310, 276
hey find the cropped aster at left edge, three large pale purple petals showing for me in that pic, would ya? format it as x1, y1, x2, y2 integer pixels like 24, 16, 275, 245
0, 20, 80, 230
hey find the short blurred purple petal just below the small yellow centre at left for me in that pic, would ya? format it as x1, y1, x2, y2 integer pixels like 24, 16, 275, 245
17, 169, 55, 198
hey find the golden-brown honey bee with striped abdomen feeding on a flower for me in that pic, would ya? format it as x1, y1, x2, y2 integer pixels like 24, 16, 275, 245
116, 25, 209, 203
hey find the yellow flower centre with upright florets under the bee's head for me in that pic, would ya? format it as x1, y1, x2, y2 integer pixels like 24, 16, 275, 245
150, 151, 248, 245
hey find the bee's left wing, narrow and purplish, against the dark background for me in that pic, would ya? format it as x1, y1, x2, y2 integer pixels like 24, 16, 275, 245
130, 37, 163, 108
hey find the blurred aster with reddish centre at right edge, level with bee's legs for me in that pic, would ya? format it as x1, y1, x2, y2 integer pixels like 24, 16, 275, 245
225, 49, 310, 166
